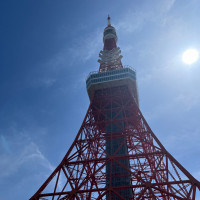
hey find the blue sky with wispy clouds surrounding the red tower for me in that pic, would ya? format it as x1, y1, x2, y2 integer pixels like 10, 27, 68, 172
0, 0, 200, 200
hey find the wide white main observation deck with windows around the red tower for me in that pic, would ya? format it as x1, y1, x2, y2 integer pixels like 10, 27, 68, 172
86, 66, 139, 105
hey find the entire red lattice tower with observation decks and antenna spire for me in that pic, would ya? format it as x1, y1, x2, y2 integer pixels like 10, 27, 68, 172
30, 16, 200, 200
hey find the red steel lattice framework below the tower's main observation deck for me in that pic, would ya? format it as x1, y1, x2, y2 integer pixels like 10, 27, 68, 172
31, 86, 200, 200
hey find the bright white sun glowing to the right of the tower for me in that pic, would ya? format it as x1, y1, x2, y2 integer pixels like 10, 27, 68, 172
182, 49, 199, 65
